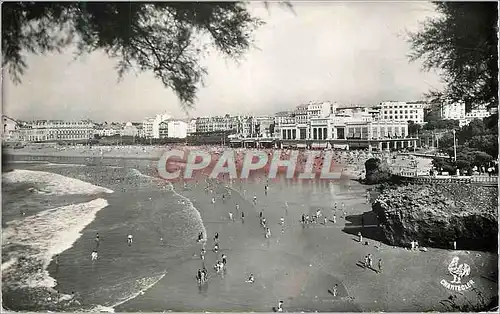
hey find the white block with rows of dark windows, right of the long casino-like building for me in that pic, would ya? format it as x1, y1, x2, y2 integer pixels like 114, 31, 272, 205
380, 101, 425, 124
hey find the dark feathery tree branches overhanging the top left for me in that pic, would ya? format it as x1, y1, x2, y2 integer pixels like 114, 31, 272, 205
2, 2, 263, 106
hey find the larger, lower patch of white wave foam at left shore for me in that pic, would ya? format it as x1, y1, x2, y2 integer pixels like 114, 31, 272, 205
2, 198, 108, 288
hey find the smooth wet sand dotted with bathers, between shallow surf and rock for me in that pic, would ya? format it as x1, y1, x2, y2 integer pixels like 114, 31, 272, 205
116, 177, 498, 312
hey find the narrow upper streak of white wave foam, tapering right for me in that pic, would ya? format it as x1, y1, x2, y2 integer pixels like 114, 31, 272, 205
2, 169, 113, 195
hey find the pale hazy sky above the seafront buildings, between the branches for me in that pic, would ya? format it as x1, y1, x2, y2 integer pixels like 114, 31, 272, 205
2, 2, 441, 122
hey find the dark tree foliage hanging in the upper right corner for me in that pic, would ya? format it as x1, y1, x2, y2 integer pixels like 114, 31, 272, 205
409, 2, 498, 111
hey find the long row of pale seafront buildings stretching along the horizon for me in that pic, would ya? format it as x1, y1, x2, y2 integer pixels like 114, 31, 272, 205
2, 101, 490, 146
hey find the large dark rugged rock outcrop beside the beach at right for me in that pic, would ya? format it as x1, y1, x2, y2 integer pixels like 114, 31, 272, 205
372, 183, 498, 252
